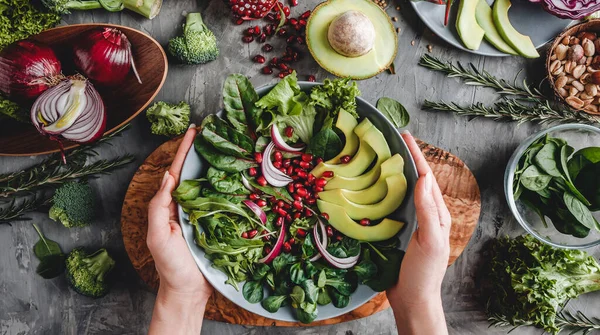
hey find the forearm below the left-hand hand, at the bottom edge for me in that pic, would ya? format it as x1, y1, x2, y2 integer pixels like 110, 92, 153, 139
148, 286, 207, 335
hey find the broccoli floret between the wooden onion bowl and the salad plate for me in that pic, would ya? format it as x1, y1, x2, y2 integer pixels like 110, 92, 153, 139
146, 101, 190, 137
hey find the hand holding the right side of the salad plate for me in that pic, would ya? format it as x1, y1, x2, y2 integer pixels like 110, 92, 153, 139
387, 132, 452, 326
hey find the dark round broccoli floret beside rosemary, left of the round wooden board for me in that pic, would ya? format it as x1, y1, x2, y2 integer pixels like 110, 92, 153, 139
50, 182, 96, 228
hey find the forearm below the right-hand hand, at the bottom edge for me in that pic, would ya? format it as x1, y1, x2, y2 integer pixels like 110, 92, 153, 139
390, 298, 448, 335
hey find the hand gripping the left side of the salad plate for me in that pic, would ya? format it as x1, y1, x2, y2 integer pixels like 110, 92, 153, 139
146, 125, 213, 303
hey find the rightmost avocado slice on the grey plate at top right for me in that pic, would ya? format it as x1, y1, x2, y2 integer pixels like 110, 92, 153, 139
492, 0, 540, 58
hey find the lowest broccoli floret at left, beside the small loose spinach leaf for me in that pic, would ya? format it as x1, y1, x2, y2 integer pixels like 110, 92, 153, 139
66, 248, 115, 298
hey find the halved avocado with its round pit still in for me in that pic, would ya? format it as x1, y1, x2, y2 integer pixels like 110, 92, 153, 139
306, 0, 398, 79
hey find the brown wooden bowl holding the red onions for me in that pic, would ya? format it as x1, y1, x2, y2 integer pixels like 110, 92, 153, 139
0, 23, 168, 156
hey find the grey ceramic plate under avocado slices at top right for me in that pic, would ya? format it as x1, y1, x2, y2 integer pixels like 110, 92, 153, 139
410, 0, 572, 57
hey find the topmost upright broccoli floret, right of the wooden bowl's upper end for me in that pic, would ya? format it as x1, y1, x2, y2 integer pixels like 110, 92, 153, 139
169, 13, 219, 64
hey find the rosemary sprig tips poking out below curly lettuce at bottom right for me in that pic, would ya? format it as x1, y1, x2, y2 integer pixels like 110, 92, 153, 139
488, 310, 600, 335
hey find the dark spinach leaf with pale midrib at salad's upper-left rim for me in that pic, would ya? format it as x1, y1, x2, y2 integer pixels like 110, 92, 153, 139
201, 115, 254, 159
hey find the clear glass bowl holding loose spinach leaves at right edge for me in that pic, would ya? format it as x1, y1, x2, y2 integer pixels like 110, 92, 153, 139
504, 124, 600, 249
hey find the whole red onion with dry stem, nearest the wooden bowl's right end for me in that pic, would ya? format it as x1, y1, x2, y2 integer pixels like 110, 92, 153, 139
73, 27, 142, 86
